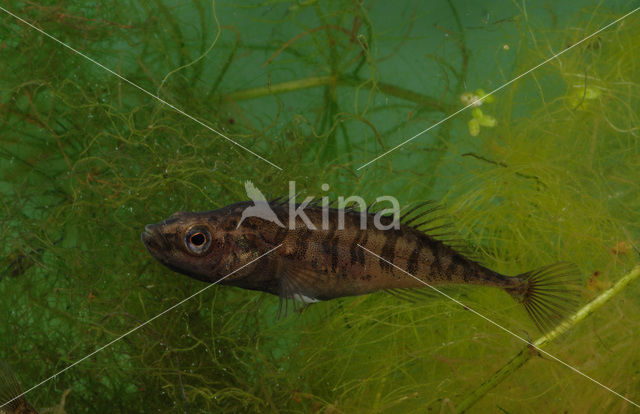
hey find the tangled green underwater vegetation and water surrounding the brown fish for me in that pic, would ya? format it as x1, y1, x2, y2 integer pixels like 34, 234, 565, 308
0, 0, 640, 413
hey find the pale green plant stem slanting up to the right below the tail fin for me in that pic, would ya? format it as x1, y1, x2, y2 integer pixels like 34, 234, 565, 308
456, 265, 640, 413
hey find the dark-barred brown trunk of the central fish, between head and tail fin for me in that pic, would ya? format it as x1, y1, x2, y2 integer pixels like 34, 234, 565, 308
272, 209, 520, 300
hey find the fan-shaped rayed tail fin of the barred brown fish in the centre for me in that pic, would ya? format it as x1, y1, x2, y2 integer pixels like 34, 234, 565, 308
506, 262, 580, 332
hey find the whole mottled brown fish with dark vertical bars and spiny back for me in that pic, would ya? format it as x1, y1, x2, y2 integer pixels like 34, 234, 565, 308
141, 199, 579, 332
